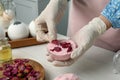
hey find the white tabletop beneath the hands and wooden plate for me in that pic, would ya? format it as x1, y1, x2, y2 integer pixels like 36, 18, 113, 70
13, 35, 120, 80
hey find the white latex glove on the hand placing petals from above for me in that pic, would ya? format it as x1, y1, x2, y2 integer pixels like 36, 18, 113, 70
35, 0, 67, 41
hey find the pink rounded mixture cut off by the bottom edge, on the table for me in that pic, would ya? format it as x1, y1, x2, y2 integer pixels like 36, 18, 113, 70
54, 73, 80, 80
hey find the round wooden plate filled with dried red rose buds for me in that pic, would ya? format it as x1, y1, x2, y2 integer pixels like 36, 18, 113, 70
0, 58, 45, 80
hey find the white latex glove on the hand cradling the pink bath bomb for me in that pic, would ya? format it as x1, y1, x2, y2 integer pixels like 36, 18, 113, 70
47, 17, 107, 66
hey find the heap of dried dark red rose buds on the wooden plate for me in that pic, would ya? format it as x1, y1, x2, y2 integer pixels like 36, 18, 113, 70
0, 59, 40, 80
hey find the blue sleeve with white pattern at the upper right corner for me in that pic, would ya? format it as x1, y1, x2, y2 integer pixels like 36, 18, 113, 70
101, 0, 120, 28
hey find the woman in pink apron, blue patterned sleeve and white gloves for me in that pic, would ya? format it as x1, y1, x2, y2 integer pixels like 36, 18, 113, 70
35, 0, 120, 66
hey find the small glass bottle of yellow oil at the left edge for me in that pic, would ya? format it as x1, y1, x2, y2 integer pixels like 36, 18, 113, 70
0, 38, 12, 63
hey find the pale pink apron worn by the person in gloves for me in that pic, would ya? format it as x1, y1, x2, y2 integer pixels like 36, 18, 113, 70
67, 0, 120, 51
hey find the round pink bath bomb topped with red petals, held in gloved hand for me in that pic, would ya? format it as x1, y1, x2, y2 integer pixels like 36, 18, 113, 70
47, 40, 77, 61
